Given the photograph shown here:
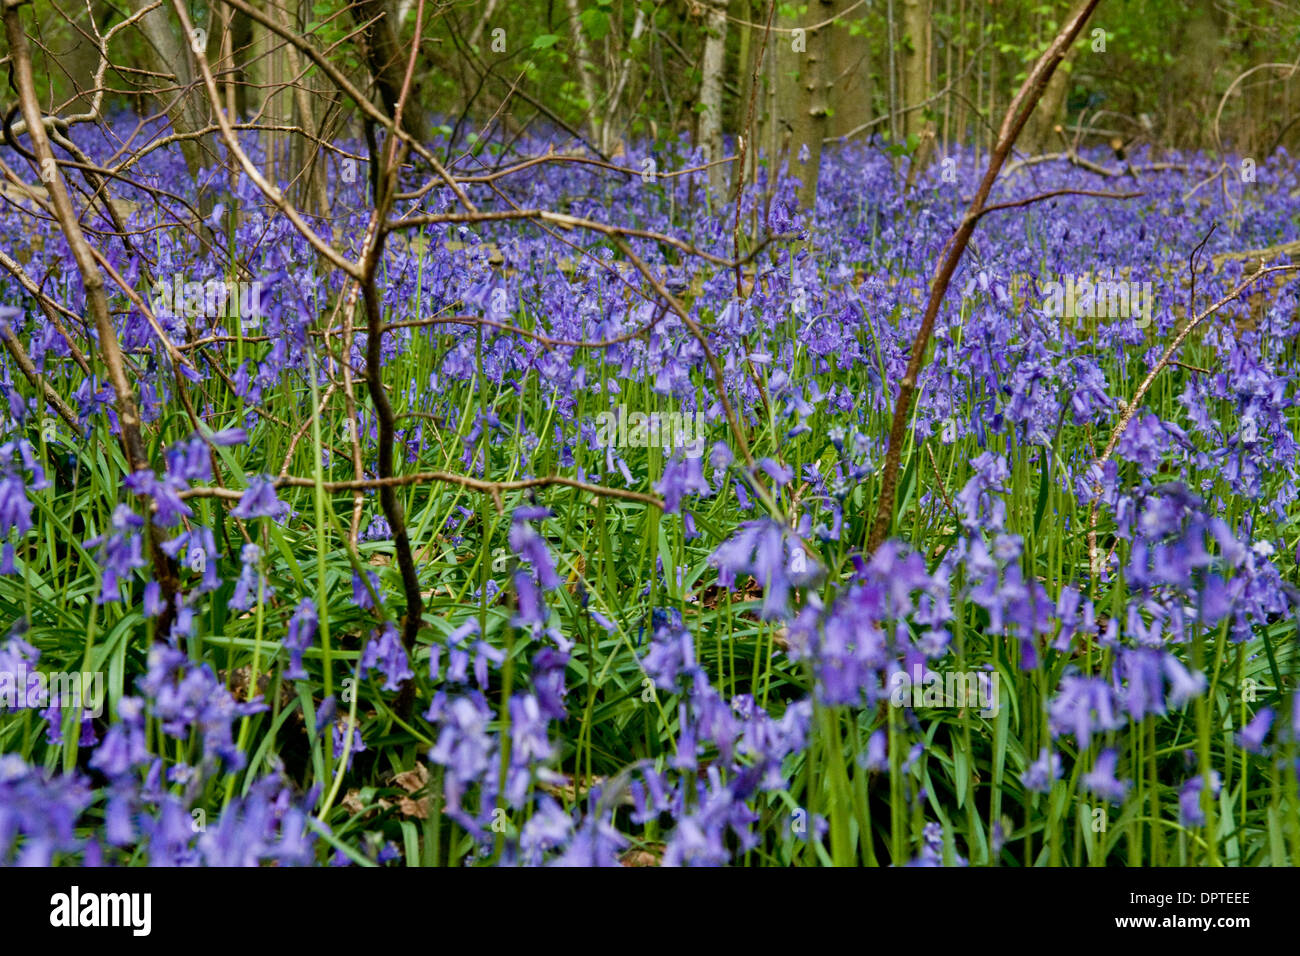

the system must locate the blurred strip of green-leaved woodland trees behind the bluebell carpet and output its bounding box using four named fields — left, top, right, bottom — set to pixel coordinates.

left=20, top=0, right=1300, bottom=206
